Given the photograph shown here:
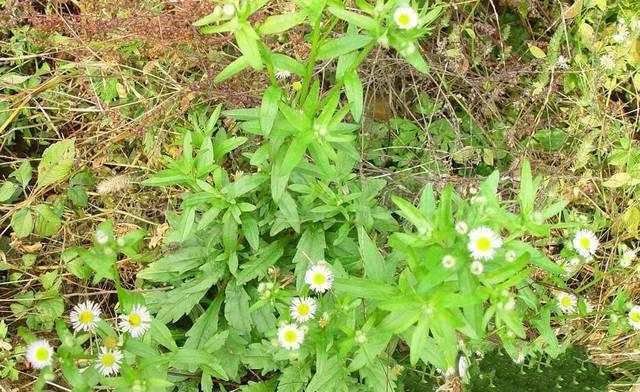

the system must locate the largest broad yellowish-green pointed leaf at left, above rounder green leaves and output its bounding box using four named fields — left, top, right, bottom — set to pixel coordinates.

left=36, top=139, right=76, bottom=189
